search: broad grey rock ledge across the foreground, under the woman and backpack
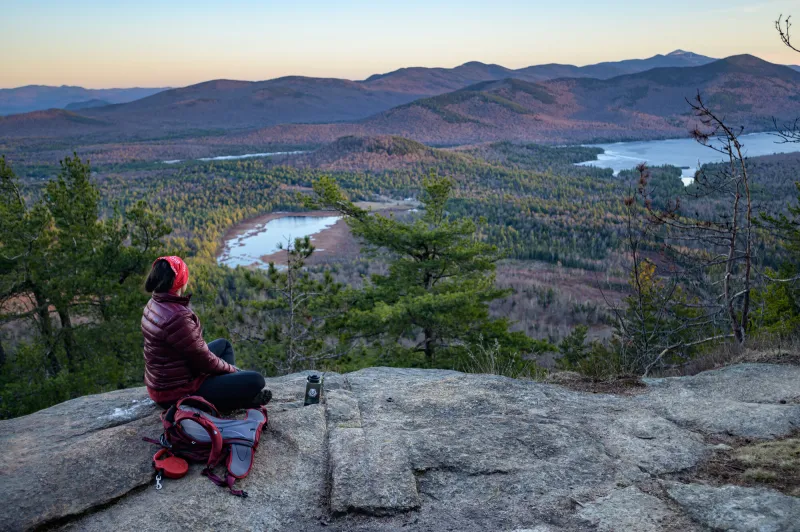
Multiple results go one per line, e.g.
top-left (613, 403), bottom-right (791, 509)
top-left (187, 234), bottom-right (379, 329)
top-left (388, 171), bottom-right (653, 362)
top-left (0, 364), bottom-right (800, 531)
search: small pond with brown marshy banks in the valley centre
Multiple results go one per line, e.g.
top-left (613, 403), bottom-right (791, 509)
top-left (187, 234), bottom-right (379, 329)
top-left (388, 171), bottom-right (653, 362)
top-left (217, 215), bottom-right (340, 268)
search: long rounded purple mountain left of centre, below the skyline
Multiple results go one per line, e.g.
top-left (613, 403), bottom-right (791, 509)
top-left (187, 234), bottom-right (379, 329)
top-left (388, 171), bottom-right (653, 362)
top-left (0, 76), bottom-right (434, 139)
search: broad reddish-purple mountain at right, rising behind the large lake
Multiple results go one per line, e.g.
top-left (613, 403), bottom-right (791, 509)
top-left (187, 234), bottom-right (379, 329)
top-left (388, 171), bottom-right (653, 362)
top-left (233, 55), bottom-right (800, 144)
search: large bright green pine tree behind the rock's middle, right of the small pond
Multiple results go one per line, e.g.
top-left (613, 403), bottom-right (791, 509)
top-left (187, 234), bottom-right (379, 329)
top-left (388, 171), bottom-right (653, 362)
top-left (306, 175), bottom-right (544, 367)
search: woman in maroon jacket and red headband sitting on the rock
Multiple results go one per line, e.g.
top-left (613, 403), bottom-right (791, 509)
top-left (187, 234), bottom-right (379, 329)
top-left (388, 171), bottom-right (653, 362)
top-left (142, 256), bottom-right (272, 410)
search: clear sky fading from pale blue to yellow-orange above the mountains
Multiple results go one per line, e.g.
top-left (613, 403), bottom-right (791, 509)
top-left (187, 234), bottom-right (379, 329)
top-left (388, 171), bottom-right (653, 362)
top-left (0, 0), bottom-right (800, 88)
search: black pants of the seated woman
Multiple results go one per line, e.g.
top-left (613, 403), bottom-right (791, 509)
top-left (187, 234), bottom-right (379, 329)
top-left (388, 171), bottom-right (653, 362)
top-left (195, 339), bottom-right (264, 410)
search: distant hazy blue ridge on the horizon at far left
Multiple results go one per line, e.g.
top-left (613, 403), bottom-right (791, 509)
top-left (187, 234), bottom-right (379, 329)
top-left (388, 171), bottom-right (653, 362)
top-left (0, 85), bottom-right (165, 116)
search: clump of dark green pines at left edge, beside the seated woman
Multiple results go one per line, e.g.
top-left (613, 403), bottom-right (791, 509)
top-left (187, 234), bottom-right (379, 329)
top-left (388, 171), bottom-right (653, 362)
top-left (0, 157), bottom-right (170, 417)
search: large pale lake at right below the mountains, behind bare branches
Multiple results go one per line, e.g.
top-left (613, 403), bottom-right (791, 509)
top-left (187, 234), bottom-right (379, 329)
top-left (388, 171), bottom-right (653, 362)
top-left (578, 133), bottom-right (800, 184)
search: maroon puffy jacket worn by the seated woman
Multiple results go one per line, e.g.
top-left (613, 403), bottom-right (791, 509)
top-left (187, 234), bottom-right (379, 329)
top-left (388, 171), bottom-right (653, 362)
top-left (142, 292), bottom-right (236, 403)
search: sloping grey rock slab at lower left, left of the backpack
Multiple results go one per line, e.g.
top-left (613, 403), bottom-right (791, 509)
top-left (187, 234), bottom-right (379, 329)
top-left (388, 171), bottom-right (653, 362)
top-left (0, 388), bottom-right (161, 530)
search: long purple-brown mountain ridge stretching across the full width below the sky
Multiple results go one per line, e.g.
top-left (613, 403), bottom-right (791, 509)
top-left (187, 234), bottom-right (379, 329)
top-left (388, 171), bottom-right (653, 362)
top-left (0, 52), bottom-right (800, 145)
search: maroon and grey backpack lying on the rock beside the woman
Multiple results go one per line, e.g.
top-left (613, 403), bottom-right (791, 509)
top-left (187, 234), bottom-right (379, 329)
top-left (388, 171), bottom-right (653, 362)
top-left (144, 396), bottom-right (268, 497)
